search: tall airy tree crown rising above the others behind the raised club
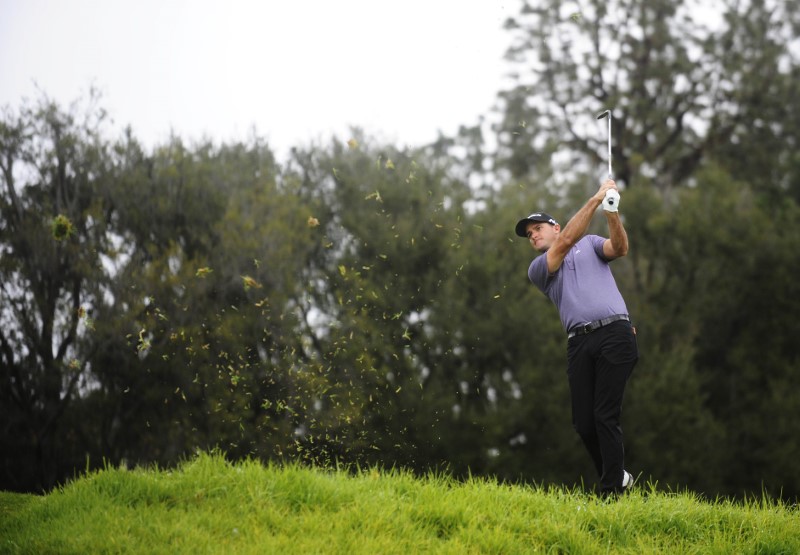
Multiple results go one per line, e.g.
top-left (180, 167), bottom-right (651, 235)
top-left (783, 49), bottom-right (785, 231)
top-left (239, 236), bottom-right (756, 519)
top-left (496, 0), bottom-right (798, 189)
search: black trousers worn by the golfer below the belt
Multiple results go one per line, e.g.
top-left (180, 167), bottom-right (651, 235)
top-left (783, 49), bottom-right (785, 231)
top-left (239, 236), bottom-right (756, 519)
top-left (567, 320), bottom-right (639, 493)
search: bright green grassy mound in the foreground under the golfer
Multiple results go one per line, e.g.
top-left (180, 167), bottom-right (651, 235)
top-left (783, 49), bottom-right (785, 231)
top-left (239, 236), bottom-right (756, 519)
top-left (0, 454), bottom-right (800, 554)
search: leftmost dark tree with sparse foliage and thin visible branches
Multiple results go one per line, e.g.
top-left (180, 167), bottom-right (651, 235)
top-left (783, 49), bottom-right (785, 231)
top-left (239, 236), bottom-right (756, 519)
top-left (0, 93), bottom-right (117, 489)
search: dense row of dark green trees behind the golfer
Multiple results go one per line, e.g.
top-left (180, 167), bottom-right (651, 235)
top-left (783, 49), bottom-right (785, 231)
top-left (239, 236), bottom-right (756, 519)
top-left (0, 0), bottom-right (800, 496)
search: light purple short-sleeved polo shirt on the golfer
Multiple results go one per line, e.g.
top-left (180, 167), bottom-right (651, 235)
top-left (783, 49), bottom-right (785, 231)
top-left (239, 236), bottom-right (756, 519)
top-left (528, 235), bottom-right (628, 331)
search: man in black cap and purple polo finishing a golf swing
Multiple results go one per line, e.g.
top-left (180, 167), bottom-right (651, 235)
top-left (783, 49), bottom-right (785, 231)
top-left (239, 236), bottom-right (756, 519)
top-left (515, 179), bottom-right (639, 495)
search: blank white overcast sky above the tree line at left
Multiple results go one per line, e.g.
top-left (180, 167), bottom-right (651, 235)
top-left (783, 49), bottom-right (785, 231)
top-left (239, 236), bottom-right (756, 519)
top-left (0, 0), bottom-right (520, 157)
